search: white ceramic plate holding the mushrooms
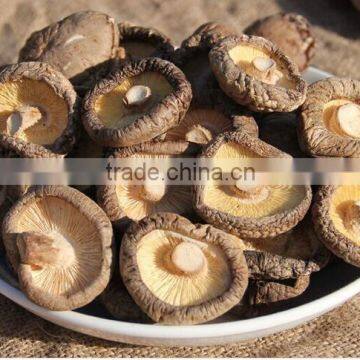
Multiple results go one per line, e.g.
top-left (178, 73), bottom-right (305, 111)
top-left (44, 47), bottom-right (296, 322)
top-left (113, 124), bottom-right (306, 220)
top-left (0, 68), bottom-right (360, 346)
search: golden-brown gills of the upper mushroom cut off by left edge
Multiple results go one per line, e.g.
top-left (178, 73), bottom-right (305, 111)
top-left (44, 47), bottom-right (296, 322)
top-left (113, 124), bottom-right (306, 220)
top-left (0, 79), bottom-right (69, 145)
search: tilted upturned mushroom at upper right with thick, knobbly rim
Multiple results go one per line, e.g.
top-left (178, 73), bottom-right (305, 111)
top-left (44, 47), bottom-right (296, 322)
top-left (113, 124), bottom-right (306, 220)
top-left (209, 35), bottom-right (307, 112)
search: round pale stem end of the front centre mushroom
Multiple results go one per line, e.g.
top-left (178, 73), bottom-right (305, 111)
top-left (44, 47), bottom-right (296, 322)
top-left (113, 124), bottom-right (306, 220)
top-left (171, 241), bottom-right (206, 274)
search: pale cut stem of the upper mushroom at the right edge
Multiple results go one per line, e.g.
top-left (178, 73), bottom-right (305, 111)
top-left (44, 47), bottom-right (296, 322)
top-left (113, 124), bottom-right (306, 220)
top-left (336, 103), bottom-right (360, 138)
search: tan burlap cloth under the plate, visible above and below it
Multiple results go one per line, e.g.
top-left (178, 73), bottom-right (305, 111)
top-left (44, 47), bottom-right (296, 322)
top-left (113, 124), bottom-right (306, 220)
top-left (0, 0), bottom-right (360, 357)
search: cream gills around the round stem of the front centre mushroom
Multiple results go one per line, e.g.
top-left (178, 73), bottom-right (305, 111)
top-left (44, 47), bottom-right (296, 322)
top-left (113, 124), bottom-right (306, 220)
top-left (137, 230), bottom-right (232, 306)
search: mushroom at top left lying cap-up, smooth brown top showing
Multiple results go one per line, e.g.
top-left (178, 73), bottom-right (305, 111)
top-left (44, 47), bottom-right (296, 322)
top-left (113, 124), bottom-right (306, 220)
top-left (19, 11), bottom-right (119, 85)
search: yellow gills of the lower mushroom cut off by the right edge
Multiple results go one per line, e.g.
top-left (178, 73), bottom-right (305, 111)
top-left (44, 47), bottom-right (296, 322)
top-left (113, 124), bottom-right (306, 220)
top-left (329, 185), bottom-right (360, 246)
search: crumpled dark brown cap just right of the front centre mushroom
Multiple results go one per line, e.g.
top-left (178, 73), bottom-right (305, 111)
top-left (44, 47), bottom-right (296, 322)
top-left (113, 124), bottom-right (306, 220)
top-left (244, 217), bottom-right (330, 280)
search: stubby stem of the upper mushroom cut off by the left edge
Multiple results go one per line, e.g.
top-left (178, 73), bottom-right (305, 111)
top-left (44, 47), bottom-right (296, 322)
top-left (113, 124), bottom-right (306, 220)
top-left (6, 105), bottom-right (46, 136)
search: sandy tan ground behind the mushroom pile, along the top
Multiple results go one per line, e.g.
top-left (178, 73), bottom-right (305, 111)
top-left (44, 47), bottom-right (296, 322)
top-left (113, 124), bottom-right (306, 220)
top-left (0, 0), bottom-right (360, 79)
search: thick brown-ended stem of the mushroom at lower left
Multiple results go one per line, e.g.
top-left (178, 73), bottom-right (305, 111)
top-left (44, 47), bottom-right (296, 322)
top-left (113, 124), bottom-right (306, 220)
top-left (16, 232), bottom-right (74, 269)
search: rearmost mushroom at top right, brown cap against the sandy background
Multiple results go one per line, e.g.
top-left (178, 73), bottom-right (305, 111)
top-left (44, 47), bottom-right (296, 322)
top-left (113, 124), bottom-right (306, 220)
top-left (244, 13), bottom-right (315, 71)
